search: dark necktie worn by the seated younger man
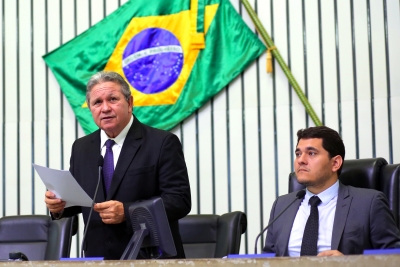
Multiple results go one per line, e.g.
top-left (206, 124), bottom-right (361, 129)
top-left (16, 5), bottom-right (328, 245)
top-left (300, 196), bottom-right (321, 256)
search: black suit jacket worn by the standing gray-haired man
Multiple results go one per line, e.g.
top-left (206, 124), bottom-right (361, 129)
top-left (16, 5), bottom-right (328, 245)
top-left (63, 118), bottom-right (191, 259)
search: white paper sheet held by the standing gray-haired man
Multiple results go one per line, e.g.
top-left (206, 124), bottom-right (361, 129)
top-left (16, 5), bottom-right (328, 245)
top-left (32, 163), bottom-right (93, 208)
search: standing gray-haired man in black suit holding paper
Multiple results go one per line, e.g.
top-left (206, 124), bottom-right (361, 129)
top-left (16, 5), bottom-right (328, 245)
top-left (45, 72), bottom-right (191, 259)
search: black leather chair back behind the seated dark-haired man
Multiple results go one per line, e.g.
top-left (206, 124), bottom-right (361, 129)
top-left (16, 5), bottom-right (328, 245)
top-left (289, 158), bottom-right (400, 228)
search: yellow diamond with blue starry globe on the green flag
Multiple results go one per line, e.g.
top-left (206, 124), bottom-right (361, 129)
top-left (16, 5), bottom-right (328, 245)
top-left (104, 4), bottom-right (218, 106)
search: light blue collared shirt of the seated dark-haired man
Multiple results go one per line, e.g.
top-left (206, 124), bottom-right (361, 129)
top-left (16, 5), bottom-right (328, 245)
top-left (288, 181), bottom-right (339, 257)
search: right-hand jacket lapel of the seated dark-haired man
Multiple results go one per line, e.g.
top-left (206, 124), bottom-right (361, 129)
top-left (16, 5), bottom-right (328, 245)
top-left (331, 182), bottom-right (353, 250)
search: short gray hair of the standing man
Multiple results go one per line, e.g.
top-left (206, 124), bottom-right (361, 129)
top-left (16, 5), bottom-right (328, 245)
top-left (86, 71), bottom-right (132, 107)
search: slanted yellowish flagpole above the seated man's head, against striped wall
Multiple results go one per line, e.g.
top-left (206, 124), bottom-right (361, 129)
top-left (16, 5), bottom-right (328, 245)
top-left (241, 0), bottom-right (322, 126)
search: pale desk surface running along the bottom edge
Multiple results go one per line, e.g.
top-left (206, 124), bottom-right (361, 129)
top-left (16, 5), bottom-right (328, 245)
top-left (0, 255), bottom-right (400, 267)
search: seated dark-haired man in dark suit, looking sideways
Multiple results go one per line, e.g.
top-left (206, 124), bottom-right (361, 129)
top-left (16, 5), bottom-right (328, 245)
top-left (263, 126), bottom-right (400, 256)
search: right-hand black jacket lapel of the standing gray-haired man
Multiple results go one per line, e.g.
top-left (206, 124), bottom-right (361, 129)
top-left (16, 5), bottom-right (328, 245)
top-left (106, 117), bottom-right (143, 200)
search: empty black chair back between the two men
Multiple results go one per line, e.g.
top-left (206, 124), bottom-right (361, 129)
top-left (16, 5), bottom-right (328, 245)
top-left (179, 211), bottom-right (247, 259)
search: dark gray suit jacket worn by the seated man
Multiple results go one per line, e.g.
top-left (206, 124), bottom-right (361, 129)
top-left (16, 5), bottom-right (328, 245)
top-left (263, 183), bottom-right (400, 256)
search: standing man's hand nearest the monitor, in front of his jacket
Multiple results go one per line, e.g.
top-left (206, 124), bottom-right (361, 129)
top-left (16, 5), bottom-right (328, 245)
top-left (93, 200), bottom-right (125, 224)
